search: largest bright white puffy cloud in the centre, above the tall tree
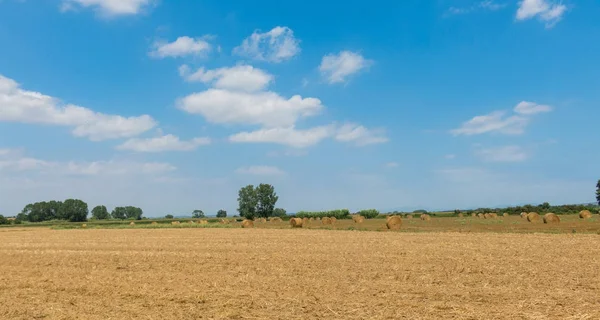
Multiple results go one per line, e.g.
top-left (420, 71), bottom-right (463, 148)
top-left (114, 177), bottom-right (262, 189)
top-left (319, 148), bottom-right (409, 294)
top-left (178, 89), bottom-right (323, 128)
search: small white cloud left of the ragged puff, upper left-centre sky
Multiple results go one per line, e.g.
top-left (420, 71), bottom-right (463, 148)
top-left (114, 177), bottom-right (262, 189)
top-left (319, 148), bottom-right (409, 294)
top-left (149, 36), bottom-right (212, 58)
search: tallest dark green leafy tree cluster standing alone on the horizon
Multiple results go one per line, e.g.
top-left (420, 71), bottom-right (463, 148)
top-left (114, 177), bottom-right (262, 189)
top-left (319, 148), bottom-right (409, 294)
top-left (238, 183), bottom-right (279, 220)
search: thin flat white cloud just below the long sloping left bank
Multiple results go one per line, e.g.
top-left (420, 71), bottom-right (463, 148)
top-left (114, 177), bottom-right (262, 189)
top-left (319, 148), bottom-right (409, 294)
top-left (117, 134), bottom-right (211, 152)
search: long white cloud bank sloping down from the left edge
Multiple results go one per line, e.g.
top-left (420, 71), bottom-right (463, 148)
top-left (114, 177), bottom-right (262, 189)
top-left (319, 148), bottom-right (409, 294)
top-left (0, 75), bottom-right (156, 141)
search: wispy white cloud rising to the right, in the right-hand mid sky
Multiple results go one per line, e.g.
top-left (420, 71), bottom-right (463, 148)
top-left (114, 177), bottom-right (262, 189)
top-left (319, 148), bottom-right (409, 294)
top-left (450, 101), bottom-right (552, 136)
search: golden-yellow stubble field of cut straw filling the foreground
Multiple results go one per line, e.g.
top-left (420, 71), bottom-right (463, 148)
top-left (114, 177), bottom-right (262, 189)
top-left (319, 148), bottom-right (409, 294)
top-left (0, 228), bottom-right (600, 319)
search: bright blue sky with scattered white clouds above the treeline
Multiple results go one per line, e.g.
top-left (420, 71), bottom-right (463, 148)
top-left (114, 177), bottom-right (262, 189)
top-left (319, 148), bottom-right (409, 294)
top-left (0, 0), bottom-right (600, 216)
